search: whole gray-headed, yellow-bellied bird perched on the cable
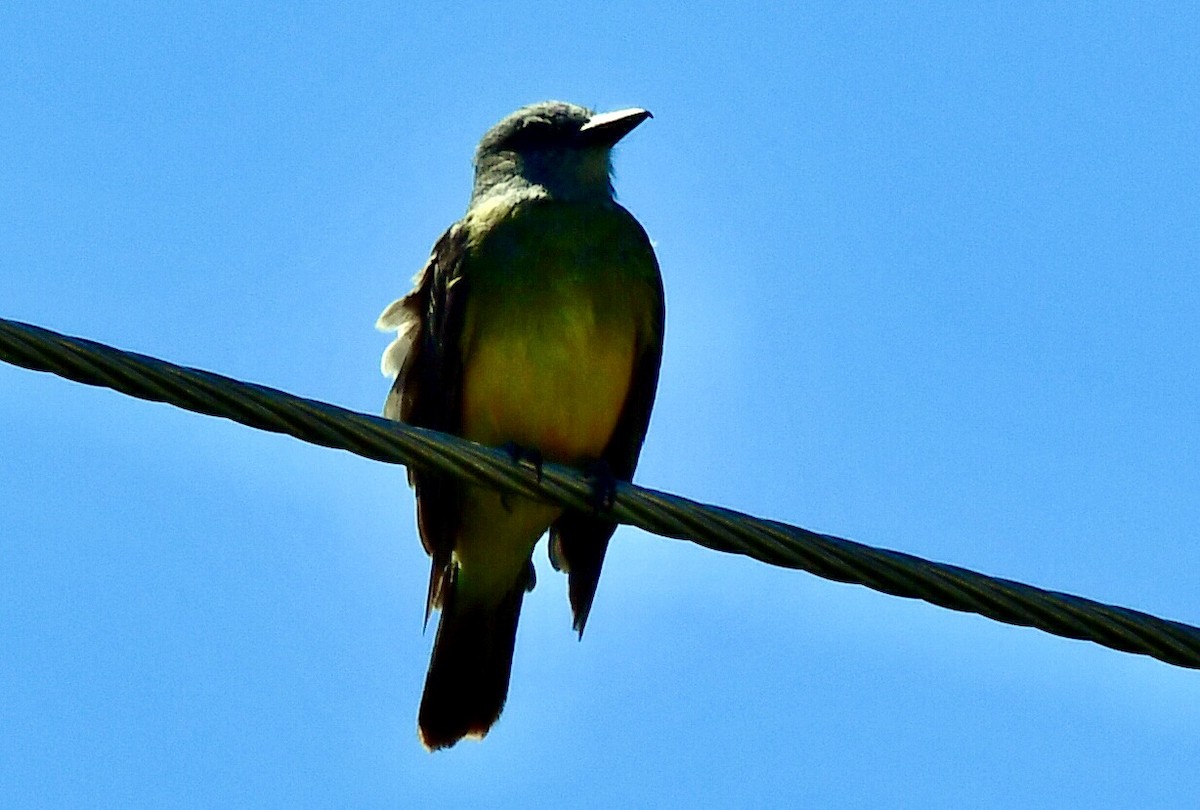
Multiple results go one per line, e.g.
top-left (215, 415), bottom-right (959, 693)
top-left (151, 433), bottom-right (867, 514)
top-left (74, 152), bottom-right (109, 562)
top-left (377, 101), bottom-right (665, 750)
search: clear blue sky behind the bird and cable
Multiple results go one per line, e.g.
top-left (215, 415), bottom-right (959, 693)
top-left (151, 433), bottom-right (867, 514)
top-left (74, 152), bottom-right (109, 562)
top-left (0, 1), bottom-right (1200, 808)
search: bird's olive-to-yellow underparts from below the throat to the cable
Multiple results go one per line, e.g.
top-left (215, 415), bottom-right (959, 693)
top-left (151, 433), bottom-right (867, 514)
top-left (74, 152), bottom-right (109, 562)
top-left (460, 203), bottom-right (658, 463)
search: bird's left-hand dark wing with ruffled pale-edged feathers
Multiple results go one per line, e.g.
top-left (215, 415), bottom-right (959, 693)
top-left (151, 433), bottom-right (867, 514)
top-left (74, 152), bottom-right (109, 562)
top-left (380, 223), bottom-right (467, 619)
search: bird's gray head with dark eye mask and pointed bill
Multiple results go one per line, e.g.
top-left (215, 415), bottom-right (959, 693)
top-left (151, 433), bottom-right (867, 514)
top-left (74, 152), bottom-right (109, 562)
top-left (472, 101), bottom-right (650, 203)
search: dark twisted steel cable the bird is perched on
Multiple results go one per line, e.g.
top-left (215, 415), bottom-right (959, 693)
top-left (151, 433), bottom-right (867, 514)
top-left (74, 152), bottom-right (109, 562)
top-left (7, 318), bottom-right (1200, 670)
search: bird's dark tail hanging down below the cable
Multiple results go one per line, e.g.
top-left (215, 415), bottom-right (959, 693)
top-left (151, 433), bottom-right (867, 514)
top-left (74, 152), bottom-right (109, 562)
top-left (418, 578), bottom-right (526, 751)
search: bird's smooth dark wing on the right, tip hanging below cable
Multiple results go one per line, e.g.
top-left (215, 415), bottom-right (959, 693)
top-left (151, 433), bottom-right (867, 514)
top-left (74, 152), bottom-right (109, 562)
top-left (550, 217), bottom-right (666, 636)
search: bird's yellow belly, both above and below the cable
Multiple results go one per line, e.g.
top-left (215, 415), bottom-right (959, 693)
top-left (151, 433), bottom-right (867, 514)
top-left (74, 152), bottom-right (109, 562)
top-left (455, 295), bottom-right (636, 600)
